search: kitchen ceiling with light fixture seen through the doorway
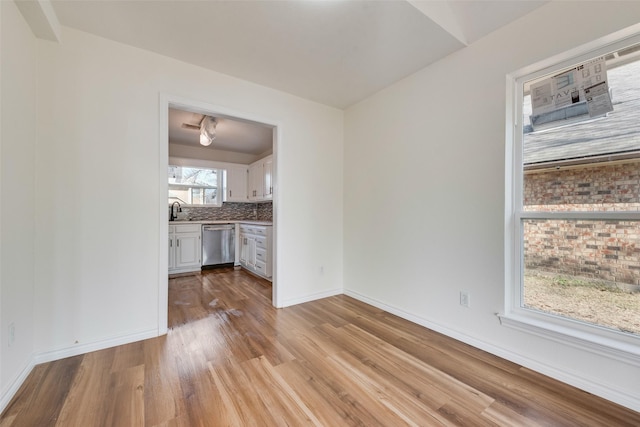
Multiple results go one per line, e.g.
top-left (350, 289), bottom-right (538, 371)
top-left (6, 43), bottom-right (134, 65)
top-left (169, 108), bottom-right (273, 156)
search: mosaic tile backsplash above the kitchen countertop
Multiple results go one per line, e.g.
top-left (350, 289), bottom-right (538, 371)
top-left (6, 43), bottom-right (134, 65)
top-left (181, 202), bottom-right (273, 221)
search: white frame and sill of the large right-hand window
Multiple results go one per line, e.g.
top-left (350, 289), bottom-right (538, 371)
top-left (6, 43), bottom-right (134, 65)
top-left (498, 25), bottom-right (640, 366)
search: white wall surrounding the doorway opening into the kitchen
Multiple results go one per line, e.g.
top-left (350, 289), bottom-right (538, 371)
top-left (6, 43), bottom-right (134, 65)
top-left (35, 28), bottom-right (343, 359)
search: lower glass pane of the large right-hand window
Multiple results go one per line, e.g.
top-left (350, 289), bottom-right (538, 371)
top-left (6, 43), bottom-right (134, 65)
top-left (522, 219), bottom-right (640, 334)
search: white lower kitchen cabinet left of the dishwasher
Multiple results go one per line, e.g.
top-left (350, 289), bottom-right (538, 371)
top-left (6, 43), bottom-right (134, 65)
top-left (169, 224), bottom-right (202, 274)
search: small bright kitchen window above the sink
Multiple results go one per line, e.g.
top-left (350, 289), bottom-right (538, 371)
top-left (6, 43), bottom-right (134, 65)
top-left (169, 166), bottom-right (222, 206)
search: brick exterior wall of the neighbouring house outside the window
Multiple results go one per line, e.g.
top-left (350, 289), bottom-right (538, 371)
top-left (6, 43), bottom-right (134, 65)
top-left (524, 161), bottom-right (640, 286)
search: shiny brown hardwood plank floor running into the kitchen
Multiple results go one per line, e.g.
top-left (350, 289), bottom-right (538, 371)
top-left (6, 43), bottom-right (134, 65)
top-left (0, 269), bottom-right (640, 427)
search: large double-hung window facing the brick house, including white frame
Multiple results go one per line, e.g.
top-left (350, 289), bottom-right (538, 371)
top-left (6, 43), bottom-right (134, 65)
top-left (501, 29), bottom-right (640, 361)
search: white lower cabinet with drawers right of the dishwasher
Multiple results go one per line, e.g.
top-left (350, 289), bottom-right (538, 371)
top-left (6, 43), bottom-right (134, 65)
top-left (240, 224), bottom-right (273, 279)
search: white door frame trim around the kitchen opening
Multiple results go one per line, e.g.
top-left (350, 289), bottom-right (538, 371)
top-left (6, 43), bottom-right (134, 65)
top-left (158, 93), bottom-right (282, 336)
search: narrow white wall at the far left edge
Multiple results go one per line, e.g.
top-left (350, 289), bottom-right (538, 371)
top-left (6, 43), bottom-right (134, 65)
top-left (0, 1), bottom-right (37, 409)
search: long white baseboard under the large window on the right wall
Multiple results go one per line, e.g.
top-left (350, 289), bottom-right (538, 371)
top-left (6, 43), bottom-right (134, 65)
top-left (344, 289), bottom-right (640, 412)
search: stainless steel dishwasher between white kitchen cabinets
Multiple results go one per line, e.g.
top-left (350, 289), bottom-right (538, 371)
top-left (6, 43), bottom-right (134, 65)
top-left (202, 224), bottom-right (236, 267)
